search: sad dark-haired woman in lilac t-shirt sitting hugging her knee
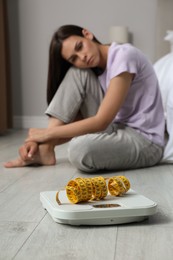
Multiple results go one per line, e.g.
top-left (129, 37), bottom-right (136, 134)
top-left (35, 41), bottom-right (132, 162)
top-left (5, 25), bottom-right (165, 172)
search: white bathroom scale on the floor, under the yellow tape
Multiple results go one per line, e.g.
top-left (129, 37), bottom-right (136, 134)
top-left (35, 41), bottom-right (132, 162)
top-left (40, 189), bottom-right (157, 225)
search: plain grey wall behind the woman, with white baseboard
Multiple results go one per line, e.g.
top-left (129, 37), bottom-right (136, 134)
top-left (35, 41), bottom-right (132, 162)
top-left (7, 0), bottom-right (170, 128)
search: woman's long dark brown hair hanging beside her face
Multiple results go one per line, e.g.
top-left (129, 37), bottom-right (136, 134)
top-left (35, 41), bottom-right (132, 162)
top-left (47, 25), bottom-right (100, 104)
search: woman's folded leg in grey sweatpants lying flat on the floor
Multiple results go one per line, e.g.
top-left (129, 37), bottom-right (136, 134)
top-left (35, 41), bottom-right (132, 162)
top-left (68, 124), bottom-right (163, 172)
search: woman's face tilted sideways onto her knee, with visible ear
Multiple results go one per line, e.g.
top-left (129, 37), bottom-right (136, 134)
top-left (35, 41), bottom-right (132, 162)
top-left (61, 29), bottom-right (101, 68)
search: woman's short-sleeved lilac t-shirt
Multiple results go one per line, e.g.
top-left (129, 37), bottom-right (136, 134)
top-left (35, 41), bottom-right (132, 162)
top-left (99, 43), bottom-right (165, 146)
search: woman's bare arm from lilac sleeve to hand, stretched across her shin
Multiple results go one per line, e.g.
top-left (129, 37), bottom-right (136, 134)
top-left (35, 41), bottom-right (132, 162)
top-left (26, 72), bottom-right (134, 143)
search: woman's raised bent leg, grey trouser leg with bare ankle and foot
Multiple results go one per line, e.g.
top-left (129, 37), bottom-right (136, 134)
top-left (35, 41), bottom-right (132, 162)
top-left (4, 67), bottom-right (103, 168)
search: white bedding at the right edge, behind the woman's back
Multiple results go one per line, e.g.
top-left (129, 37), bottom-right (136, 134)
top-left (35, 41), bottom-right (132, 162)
top-left (154, 52), bottom-right (173, 163)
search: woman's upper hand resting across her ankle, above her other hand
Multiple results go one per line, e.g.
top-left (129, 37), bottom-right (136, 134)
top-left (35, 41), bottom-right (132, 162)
top-left (25, 128), bottom-right (51, 143)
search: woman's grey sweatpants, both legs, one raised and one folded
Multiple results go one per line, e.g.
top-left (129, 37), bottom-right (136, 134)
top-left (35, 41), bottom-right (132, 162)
top-left (46, 67), bottom-right (163, 172)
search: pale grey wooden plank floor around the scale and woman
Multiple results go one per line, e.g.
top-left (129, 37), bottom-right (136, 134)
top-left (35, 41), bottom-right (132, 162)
top-left (0, 130), bottom-right (173, 260)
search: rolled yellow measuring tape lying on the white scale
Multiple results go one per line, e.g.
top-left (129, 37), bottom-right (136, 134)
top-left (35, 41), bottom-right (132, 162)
top-left (56, 176), bottom-right (130, 205)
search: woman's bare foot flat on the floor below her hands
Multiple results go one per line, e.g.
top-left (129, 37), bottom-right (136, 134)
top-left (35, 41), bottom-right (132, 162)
top-left (4, 144), bottom-right (56, 168)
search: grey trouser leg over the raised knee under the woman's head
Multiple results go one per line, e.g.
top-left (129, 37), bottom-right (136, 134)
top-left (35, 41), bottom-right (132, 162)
top-left (46, 67), bottom-right (103, 120)
